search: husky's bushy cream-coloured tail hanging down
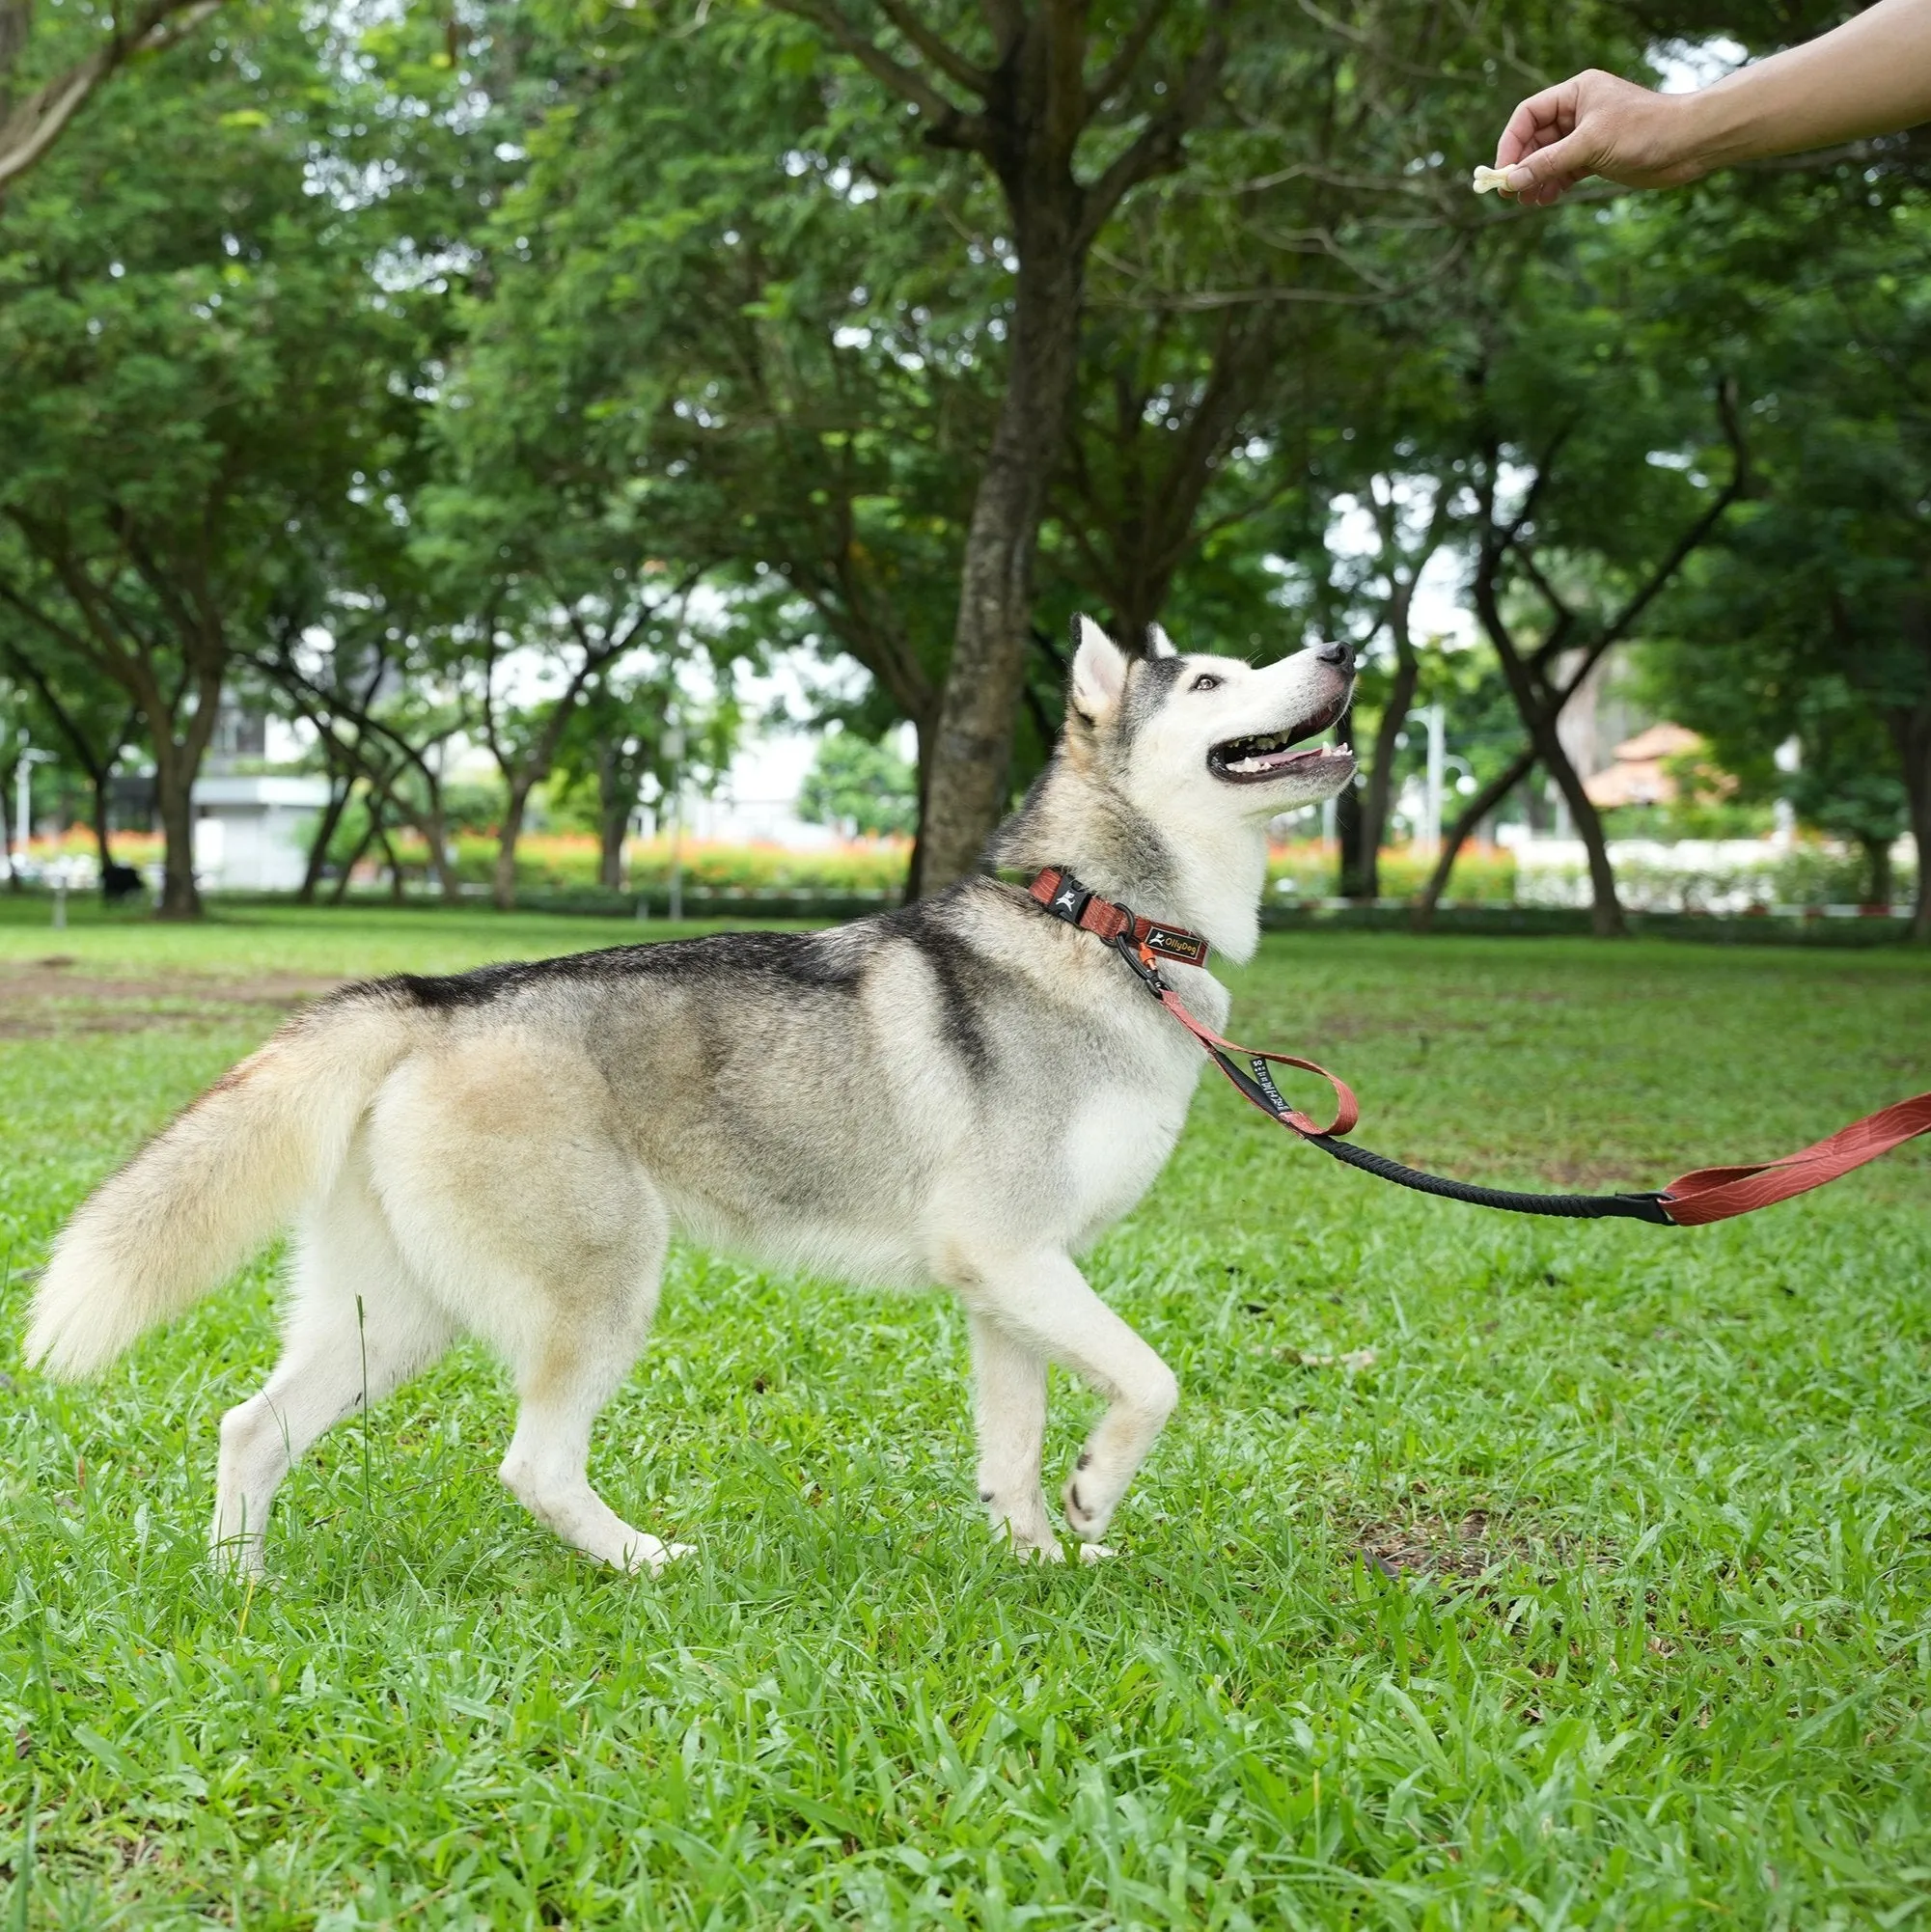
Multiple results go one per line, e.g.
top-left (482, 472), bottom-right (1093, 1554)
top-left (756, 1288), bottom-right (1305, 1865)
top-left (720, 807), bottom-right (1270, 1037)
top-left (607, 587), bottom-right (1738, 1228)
top-left (27, 987), bottom-right (417, 1381)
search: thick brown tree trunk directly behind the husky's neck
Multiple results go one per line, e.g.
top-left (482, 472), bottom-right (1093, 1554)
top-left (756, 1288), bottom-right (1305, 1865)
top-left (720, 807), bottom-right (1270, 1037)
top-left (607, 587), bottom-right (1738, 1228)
top-left (913, 196), bottom-right (1082, 895)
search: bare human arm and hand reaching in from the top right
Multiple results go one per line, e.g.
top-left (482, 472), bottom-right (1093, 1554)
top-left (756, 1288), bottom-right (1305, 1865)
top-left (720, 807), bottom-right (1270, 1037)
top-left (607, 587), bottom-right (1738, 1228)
top-left (1495, 0), bottom-right (1931, 207)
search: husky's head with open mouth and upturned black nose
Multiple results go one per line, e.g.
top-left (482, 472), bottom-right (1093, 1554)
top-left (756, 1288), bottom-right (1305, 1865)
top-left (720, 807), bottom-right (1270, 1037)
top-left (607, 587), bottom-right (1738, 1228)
top-left (1066, 617), bottom-right (1354, 825)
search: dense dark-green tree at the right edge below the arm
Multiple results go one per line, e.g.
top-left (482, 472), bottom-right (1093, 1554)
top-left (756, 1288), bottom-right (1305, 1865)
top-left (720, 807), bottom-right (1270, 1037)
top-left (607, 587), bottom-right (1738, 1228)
top-left (1614, 170), bottom-right (1931, 941)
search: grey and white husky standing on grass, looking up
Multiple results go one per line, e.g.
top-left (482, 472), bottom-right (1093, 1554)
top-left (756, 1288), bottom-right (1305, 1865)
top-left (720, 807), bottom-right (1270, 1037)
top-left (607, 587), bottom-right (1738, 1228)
top-left (27, 619), bottom-right (1354, 1571)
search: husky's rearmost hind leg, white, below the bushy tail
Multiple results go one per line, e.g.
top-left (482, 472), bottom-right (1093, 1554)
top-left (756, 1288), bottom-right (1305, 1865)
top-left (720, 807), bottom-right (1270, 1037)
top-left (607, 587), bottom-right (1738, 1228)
top-left (208, 1147), bottom-right (452, 1575)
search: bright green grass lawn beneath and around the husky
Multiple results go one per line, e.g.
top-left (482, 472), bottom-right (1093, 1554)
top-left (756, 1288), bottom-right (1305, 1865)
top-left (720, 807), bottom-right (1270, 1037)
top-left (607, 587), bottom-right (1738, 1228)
top-left (0, 902), bottom-right (1931, 1928)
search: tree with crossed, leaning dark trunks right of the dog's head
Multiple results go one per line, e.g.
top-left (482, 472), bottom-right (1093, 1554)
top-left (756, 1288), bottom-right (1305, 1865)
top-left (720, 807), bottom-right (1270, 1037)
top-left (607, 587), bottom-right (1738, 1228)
top-left (1418, 186), bottom-right (1752, 937)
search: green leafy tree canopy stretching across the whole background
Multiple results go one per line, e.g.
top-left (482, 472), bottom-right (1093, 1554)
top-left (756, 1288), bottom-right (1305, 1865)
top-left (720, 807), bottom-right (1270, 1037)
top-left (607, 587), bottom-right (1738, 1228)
top-left (11, 0), bottom-right (1931, 919)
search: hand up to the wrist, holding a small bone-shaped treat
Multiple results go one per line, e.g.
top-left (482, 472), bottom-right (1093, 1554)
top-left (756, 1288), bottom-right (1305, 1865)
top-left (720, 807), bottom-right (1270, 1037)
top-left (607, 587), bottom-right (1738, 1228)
top-left (1495, 68), bottom-right (1709, 208)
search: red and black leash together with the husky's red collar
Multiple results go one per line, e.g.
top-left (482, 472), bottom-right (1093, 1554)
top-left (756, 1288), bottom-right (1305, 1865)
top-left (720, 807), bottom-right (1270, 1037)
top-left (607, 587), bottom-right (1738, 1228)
top-left (1030, 866), bottom-right (1931, 1227)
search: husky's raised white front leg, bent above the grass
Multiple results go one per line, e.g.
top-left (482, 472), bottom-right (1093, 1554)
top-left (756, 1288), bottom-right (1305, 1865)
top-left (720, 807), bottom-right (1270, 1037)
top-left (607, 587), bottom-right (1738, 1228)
top-left (959, 1252), bottom-right (1180, 1546)
